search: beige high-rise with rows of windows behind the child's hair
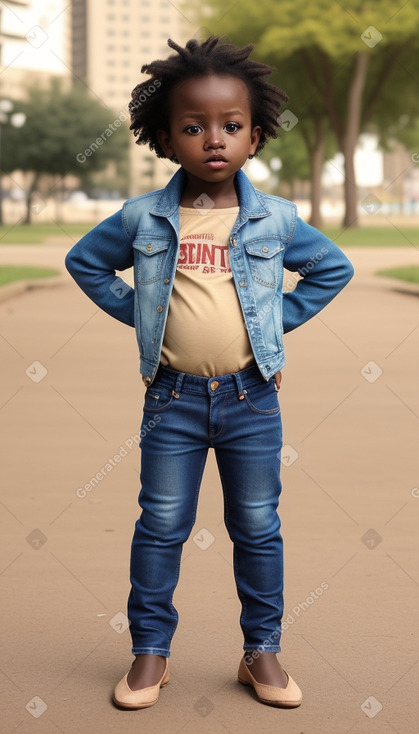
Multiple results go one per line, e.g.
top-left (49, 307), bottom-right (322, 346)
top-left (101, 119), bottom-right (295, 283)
top-left (72, 0), bottom-right (190, 195)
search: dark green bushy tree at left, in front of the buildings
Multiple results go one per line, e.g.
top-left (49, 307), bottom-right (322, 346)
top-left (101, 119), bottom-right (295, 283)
top-left (2, 79), bottom-right (129, 223)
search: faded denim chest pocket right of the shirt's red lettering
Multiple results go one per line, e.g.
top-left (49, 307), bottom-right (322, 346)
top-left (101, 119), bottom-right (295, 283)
top-left (244, 237), bottom-right (285, 288)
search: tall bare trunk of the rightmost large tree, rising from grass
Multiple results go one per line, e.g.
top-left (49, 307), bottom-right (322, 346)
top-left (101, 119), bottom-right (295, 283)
top-left (342, 51), bottom-right (369, 227)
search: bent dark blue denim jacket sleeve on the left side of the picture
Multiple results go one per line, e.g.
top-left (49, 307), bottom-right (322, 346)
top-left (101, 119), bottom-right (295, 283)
top-left (65, 209), bottom-right (134, 326)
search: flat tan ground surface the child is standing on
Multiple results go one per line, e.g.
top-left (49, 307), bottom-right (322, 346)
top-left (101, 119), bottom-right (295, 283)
top-left (0, 246), bottom-right (419, 734)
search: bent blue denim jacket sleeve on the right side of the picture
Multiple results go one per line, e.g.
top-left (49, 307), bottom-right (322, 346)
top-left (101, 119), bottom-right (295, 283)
top-left (283, 217), bottom-right (354, 333)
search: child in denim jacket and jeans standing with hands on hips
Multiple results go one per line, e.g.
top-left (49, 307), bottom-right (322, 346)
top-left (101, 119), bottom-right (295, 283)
top-left (66, 38), bottom-right (353, 709)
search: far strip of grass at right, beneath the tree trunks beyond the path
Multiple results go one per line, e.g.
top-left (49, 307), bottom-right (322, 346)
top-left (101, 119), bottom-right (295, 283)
top-left (322, 227), bottom-right (419, 247)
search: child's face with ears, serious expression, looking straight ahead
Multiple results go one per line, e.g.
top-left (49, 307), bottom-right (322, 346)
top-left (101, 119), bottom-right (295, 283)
top-left (158, 74), bottom-right (261, 190)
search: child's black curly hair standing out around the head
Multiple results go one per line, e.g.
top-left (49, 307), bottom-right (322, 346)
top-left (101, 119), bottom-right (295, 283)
top-left (128, 36), bottom-right (288, 158)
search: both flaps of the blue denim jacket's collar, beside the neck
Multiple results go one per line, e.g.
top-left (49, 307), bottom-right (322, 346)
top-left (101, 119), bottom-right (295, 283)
top-left (150, 168), bottom-right (271, 221)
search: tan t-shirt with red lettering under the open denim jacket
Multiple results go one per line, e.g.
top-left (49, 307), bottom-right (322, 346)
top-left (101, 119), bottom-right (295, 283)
top-left (161, 206), bottom-right (255, 377)
